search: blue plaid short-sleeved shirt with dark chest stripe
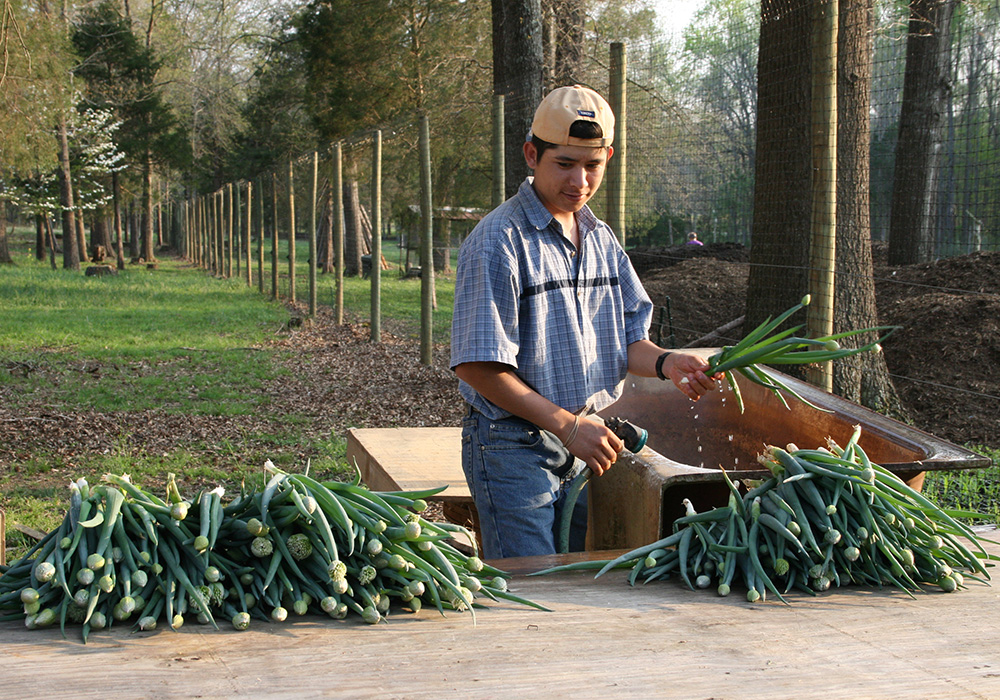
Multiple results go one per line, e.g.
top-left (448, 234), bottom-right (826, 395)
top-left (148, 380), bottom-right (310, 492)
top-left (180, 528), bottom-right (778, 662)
top-left (451, 178), bottom-right (653, 419)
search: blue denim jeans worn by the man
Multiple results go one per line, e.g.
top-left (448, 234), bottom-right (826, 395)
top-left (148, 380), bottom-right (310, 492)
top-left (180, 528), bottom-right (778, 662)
top-left (462, 409), bottom-right (587, 559)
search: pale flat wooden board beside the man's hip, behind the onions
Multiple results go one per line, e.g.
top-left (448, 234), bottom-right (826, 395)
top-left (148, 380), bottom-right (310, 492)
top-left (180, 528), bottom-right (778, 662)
top-left (347, 428), bottom-right (472, 503)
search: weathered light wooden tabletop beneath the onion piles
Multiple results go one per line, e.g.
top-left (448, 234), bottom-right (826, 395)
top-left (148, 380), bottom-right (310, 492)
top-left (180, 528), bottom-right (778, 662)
top-left (0, 546), bottom-right (1000, 700)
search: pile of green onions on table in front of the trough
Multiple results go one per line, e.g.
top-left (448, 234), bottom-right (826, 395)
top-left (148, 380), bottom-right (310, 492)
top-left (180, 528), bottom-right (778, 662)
top-left (533, 428), bottom-right (998, 602)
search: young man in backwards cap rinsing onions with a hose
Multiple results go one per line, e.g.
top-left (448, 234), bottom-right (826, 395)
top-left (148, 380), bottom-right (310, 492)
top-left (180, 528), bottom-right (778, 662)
top-left (451, 85), bottom-right (715, 558)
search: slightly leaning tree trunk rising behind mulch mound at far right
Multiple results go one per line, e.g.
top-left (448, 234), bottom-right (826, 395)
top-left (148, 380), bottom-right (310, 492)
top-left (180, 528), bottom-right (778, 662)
top-left (889, 0), bottom-right (955, 265)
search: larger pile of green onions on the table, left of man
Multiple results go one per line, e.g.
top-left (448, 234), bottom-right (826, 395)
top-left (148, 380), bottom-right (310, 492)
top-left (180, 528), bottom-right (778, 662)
top-left (0, 462), bottom-right (544, 642)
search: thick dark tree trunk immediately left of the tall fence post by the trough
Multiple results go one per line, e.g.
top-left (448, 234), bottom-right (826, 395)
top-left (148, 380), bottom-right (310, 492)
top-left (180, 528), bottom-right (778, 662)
top-left (744, 0), bottom-right (812, 356)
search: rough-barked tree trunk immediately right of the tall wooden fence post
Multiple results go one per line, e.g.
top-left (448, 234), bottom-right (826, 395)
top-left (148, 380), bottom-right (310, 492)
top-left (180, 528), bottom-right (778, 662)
top-left (833, 0), bottom-right (905, 418)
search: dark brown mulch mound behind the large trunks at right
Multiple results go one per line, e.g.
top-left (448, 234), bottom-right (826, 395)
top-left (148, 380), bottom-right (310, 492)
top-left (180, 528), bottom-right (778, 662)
top-left (632, 244), bottom-right (1000, 447)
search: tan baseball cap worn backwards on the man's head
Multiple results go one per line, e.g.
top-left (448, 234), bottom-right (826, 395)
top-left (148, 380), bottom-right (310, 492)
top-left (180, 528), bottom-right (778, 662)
top-left (531, 85), bottom-right (615, 148)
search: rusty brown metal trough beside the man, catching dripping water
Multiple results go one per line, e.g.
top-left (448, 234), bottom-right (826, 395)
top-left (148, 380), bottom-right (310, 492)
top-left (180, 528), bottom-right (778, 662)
top-left (588, 360), bottom-right (990, 549)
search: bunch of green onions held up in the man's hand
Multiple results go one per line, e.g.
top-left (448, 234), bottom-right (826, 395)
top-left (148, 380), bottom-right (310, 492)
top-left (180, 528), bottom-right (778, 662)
top-left (706, 294), bottom-right (896, 413)
